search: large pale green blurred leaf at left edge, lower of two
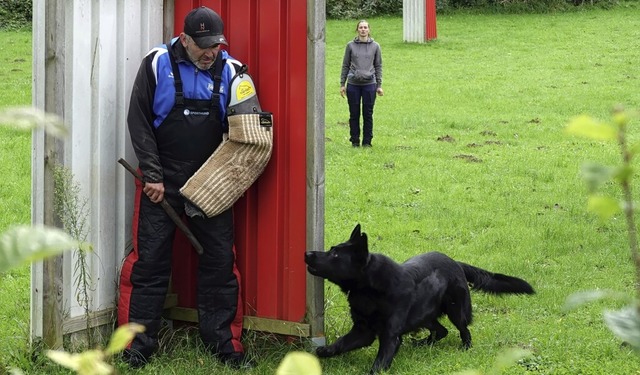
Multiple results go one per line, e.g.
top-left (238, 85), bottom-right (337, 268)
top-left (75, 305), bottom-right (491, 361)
top-left (0, 225), bottom-right (80, 273)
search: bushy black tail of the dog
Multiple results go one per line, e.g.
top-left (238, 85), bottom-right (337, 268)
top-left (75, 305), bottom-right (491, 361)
top-left (458, 262), bottom-right (535, 294)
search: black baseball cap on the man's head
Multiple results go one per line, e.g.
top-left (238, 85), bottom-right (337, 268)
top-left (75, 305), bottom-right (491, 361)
top-left (184, 7), bottom-right (229, 48)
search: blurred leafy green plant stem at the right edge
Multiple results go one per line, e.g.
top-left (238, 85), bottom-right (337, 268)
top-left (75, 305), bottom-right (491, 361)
top-left (566, 108), bottom-right (640, 351)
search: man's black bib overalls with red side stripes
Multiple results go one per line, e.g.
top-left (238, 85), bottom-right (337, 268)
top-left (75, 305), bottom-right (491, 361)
top-left (118, 45), bottom-right (243, 359)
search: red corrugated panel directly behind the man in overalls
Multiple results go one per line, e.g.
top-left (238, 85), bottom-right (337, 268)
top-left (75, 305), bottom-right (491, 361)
top-left (172, 0), bottom-right (307, 322)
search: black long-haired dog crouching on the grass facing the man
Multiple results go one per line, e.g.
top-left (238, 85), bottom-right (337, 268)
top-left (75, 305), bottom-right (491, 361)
top-left (305, 224), bottom-right (535, 374)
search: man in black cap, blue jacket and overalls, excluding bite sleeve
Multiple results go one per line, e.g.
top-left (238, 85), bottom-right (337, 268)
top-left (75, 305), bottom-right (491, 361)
top-left (118, 7), bottom-right (251, 368)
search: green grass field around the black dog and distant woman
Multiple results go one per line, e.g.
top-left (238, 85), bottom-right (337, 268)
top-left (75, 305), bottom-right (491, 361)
top-left (0, 3), bottom-right (640, 374)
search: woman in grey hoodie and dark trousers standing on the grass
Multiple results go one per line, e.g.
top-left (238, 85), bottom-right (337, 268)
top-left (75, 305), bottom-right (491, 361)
top-left (340, 20), bottom-right (384, 147)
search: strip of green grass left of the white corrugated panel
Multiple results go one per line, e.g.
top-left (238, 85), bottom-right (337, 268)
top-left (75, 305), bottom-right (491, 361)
top-left (0, 32), bottom-right (31, 374)
